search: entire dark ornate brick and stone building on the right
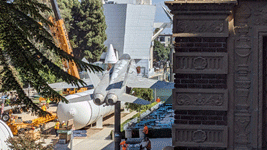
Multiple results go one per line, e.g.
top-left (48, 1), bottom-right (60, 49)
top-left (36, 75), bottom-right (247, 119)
top-left (165, 0), bottom-right (267, 150)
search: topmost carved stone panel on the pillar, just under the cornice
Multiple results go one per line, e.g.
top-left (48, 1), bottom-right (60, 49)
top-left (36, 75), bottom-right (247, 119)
top-left (174, 19), bottom-right (224, 33)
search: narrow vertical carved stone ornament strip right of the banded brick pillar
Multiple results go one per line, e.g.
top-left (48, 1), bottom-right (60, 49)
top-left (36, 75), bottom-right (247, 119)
top-left (234, 4), bottom-right (251, 150)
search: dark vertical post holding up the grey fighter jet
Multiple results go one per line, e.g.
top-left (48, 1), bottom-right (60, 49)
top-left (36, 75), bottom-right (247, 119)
top-left (114, 101), bottom-right (121, 150)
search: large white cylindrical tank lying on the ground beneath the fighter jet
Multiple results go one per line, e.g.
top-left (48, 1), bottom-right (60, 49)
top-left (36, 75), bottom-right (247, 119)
top-left (57, 90), bottom-right (124, 129)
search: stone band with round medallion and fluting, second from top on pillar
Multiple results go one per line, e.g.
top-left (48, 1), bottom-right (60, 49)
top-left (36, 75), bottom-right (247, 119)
top-left (174, 53), bottom-right (228, 74)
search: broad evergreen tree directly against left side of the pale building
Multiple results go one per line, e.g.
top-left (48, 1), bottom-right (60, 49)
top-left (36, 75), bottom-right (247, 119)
top-left (70, 0), bottom-right (107, 62)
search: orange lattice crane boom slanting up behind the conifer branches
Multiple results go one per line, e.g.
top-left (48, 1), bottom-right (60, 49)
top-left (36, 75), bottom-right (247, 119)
top-left (48, 0), bottom-right (80, 79)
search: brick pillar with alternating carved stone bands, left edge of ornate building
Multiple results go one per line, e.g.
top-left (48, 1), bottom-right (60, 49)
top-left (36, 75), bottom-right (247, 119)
top-left (165, 0), bottom-right (238, 149)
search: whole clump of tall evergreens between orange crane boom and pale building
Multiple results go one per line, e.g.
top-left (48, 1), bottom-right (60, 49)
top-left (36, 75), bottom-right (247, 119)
top-left (40, 0), bottom-right (107, 62)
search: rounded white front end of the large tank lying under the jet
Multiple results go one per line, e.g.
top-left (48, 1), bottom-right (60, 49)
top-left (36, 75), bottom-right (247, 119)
top-left (57, 101), bottom-right (92, 129)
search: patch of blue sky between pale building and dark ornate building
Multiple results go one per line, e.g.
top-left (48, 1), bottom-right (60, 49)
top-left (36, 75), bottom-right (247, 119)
top-left (152, 0), bottom-right (172, 34)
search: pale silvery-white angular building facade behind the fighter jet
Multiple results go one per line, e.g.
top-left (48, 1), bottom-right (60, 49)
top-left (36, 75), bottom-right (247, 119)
top-left (103, 0), bottom-right (156, 77)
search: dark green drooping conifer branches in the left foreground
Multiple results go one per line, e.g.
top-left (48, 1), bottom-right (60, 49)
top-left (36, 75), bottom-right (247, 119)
top-left (0, 0), bottom-right (102, 115)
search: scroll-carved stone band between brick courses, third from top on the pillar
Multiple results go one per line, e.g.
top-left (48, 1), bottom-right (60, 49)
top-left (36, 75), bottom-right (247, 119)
top-left (173, 89), bottom-right (228, 110)
